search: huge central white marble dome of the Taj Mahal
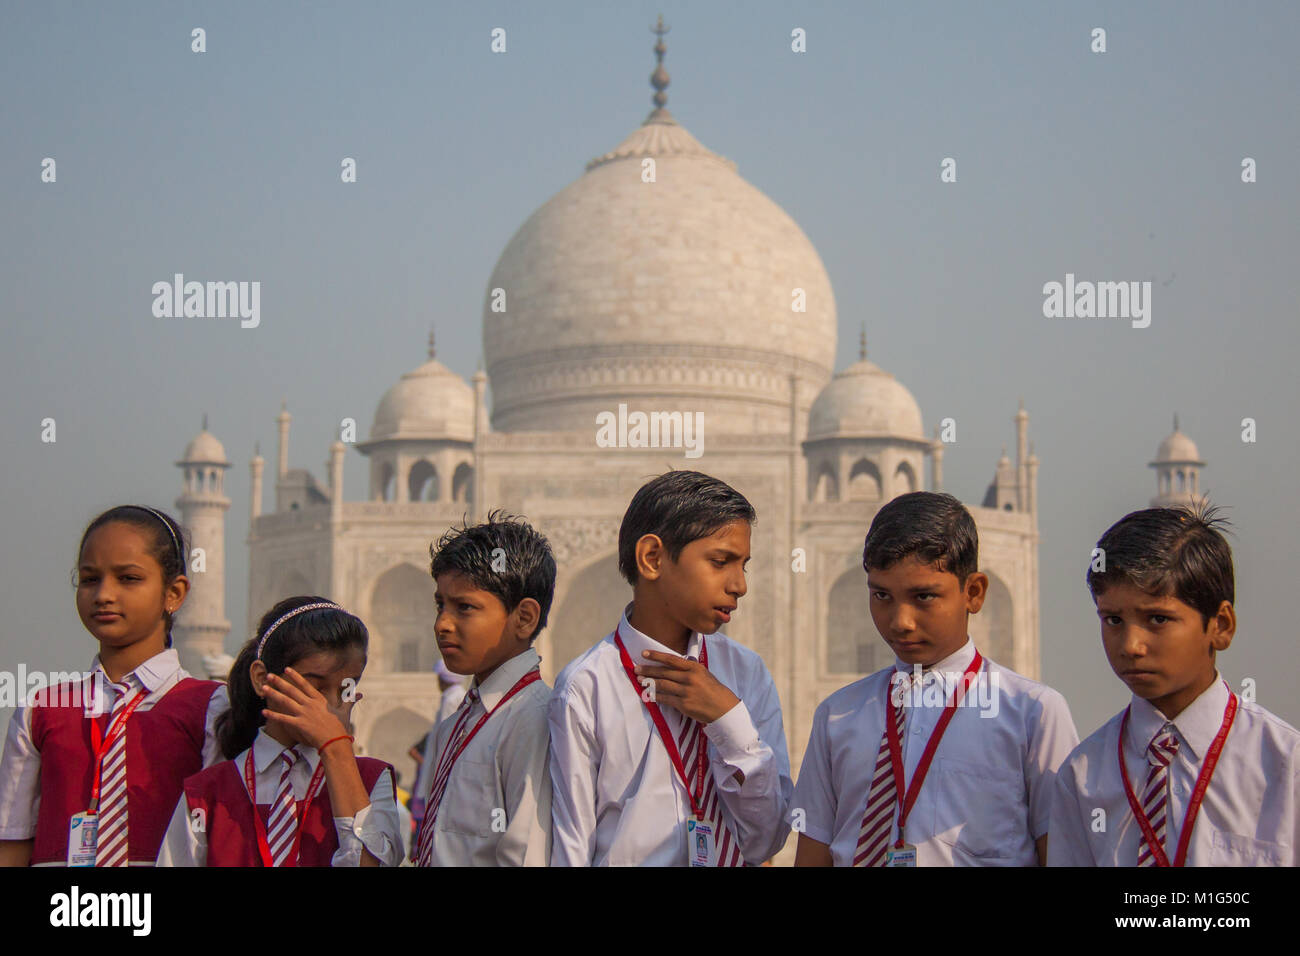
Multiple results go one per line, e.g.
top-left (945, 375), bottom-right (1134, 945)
top-left (484, 109), bottom-right (836, 433)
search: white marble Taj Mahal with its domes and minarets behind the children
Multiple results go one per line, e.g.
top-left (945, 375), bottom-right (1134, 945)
top-left (154, 35), bottom-right (1204, 786)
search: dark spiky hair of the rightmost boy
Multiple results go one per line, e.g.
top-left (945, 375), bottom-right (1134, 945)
top-left (1088, 502), bottom-right (1236, 630)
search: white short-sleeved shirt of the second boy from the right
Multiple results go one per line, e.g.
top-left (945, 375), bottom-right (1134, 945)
top-left (790, 637), bottom-right (1079, 866)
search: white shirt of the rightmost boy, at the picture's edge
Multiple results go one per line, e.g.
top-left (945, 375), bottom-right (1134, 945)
top-left (1048, 672), bottom-right (1300, 866)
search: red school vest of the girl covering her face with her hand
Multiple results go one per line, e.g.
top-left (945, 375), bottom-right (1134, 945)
top-left (185, 754), bottom-right (397, 866)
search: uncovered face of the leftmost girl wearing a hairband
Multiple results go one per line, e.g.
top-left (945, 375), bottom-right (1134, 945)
top-left (77, 522), bottom-right (190, 652)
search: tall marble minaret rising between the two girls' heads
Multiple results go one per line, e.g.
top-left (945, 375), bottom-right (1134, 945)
top-left (172, 415), bottom-right (230, 676)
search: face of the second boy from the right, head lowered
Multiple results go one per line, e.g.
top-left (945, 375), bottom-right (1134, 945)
top-left (867, 557), bottom-right (988, 667)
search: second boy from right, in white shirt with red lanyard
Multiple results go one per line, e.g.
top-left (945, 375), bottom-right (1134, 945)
top-left (790, 492), bottom-right (1079, 866)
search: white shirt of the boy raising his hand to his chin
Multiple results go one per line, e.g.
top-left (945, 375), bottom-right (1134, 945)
top-left (550, 605), bottom-right (793, 866)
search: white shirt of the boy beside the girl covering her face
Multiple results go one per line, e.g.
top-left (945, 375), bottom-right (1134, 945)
top-left (424, 648), bottom-right (551, 866)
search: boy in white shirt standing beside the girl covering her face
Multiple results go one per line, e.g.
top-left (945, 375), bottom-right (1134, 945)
top-left (415, 511), bottom-right (555, 866)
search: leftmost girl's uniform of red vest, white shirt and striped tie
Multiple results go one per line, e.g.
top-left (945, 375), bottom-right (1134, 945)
top-left (0, 649), bottom-right (229, 866)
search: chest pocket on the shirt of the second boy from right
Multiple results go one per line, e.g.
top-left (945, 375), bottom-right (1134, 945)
top-left (923, 757), bottom-right (1030, 865)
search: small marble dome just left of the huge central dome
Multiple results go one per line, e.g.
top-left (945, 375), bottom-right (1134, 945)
top-left (371, 358), bottom-right (475, 441)
